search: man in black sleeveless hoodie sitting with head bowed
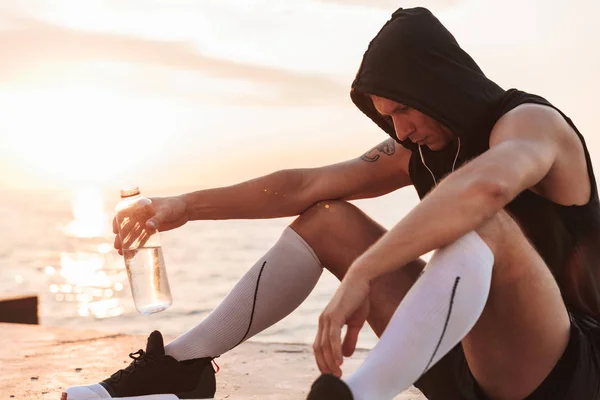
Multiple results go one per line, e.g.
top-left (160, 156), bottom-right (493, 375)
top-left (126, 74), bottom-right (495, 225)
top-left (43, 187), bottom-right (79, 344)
top-left (63, 8), bottom-right (600, 400)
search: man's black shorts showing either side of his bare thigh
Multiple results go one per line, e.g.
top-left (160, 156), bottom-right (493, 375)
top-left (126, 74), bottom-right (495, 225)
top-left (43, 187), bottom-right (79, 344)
top-left (415, 313), bottom-right (600, 400)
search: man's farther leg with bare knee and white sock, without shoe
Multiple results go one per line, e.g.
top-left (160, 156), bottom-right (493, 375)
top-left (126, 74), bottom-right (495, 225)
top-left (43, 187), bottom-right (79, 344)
top-left (166, 201), bottom-right (424, 360)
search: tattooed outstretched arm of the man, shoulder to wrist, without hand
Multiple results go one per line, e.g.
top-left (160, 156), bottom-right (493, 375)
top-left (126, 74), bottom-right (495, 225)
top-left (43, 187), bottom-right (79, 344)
top-left (181, 139), bottom-right (411, 220)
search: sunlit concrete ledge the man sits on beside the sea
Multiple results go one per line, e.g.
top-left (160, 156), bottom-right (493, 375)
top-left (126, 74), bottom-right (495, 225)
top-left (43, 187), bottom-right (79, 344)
top-left (0, 323), bottom-right (425, 400)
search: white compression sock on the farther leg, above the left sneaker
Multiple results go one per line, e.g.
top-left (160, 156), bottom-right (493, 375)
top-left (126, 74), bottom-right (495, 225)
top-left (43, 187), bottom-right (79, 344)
top-left (165, 227), bottom-right (323, 361)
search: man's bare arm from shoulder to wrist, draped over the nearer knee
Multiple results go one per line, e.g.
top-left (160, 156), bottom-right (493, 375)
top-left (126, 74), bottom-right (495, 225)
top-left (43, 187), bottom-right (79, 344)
top-left (349, 106), bottom-right (566, 281)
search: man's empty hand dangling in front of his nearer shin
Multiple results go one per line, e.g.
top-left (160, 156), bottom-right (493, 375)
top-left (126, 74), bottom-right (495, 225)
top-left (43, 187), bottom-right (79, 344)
top-left (313, 275), bottom-right (370, 378)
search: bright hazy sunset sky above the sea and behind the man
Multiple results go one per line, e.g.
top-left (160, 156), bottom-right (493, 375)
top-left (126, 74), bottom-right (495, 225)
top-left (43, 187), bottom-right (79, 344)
top-left (0, 0), bottom-right (600, 194)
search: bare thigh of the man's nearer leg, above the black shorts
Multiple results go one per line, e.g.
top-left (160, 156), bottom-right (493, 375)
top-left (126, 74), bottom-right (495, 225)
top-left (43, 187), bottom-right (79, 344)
top-left (462, 211), bottom-right (570, 400)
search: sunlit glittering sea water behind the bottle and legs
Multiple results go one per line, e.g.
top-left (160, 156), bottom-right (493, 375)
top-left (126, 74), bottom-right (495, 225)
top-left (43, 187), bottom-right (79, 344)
top-left (0, 186), bottom-right (418, 348)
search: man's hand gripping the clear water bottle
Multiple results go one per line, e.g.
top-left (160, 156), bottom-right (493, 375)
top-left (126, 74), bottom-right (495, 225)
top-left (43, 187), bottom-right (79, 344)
top-left (113, 196), bottom-right (188, 255)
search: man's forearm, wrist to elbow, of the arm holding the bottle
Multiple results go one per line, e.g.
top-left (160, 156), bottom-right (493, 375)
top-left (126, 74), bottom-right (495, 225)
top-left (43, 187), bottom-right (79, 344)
top-left (181, 169), bottom-right (312, 220)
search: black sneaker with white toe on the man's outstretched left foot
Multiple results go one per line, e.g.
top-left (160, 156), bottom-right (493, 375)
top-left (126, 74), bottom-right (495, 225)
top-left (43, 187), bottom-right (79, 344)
top-left (61, 331), bottom-right (216, 400)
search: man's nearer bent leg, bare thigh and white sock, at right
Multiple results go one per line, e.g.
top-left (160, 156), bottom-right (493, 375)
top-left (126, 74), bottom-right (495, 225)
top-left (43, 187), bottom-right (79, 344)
top-left (309, 211), bottom-right (570, 400)
